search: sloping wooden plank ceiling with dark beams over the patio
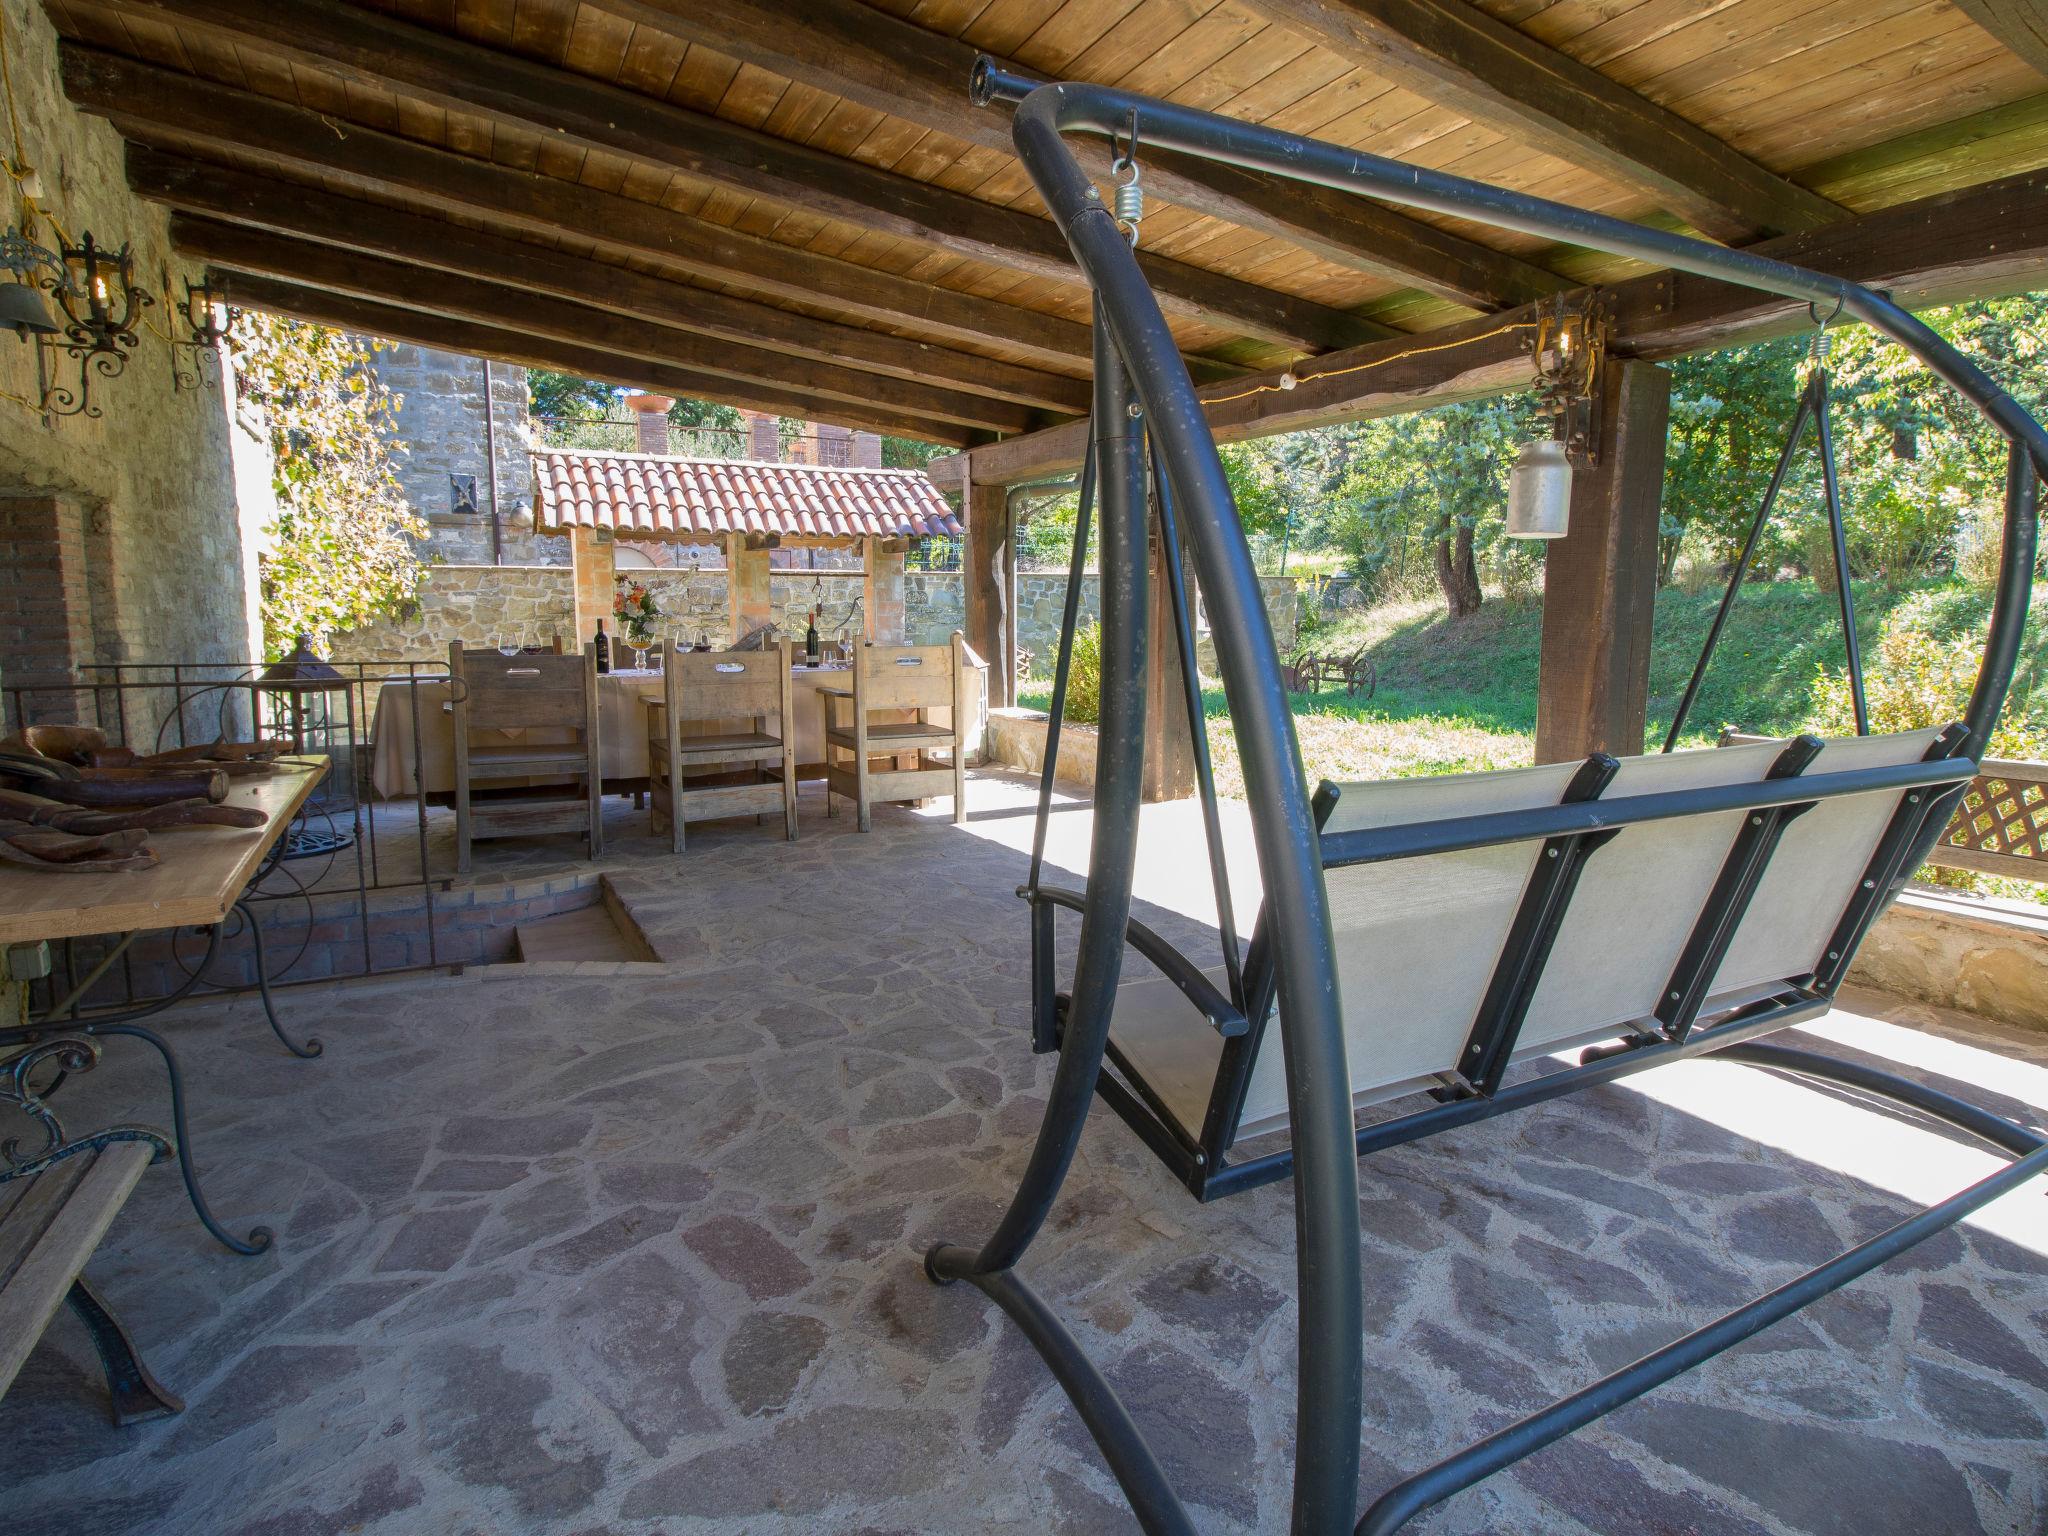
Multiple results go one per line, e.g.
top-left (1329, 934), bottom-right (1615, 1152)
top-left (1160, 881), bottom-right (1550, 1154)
top-left (47, 0), bottom-right (2048, 446)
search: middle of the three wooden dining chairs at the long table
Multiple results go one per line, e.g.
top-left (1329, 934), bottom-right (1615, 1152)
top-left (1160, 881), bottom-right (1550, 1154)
top-left (647, 639), bottom-right (797, 854)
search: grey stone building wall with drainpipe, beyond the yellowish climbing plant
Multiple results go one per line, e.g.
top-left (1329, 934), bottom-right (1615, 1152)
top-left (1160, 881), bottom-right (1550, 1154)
top-left (375, 344), bottom-right (569, 565)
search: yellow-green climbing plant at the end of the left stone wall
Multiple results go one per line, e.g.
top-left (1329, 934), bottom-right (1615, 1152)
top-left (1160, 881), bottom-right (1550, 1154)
top-left (233, 309), bottom-right (428, 655)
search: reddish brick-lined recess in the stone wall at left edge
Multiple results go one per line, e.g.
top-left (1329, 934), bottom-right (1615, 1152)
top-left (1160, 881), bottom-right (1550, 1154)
top-left (0, 496), bottom-right (92, 725)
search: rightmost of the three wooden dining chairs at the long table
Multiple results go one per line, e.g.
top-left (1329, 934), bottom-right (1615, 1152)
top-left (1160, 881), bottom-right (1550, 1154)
top-left (819, 631), bottom-right (969, 831)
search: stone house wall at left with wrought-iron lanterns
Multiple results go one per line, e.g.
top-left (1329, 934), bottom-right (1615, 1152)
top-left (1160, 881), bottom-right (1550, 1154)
top-left (0, 0), bottom-right (256, 731)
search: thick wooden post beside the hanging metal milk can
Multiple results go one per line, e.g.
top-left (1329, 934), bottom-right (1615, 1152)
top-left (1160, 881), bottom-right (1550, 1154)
top-left (1536, 358), bottom-right (1671, 762)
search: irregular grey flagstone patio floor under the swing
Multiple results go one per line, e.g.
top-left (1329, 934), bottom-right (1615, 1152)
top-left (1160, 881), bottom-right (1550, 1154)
top-left (0, 776), bottom-right (2048, 1536)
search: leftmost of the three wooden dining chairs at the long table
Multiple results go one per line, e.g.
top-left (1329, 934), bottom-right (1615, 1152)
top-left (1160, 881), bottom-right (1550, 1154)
top-left (449, 641), bottom-right (604, 874)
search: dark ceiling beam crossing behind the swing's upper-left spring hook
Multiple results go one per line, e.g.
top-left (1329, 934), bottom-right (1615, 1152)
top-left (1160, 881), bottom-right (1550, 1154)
top-left (569, 0), bottom-right (1567, 309)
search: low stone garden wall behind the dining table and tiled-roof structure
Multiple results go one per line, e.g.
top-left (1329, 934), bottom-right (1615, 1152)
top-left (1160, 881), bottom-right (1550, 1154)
top-left (334, 565), bottom-right (1294, 674)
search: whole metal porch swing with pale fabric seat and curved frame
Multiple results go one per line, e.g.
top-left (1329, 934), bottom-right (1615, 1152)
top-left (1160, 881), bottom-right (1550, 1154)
top-left (924, 59), bottom-right (2048, 1536)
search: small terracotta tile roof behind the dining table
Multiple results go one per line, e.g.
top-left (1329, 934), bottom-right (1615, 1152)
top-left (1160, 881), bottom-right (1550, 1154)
top-left (532, 449), bottom-right (961, 539)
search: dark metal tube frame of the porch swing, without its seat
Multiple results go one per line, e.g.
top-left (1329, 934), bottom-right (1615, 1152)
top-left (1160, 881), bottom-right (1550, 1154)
top-left (926, 59), bottom-right (2048, 1536)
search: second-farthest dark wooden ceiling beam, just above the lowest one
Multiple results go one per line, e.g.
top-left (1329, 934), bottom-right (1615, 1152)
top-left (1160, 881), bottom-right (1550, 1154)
top-left (170, 213), bottom-right (1042, 432)
